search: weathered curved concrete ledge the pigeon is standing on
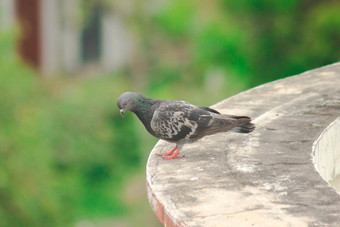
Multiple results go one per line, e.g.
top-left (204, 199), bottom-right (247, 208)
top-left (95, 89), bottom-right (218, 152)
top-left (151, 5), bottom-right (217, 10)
top-left (147, 63), bottom-right (340, 227)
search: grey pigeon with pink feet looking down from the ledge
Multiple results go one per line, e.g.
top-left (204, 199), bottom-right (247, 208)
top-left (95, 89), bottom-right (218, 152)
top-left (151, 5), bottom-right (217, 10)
top-left (117, 92), bottom-right (255, 160)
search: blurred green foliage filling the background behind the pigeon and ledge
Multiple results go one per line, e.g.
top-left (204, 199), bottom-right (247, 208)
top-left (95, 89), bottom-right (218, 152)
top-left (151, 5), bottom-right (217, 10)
top-left (0, 0), bottom-right (340, 226)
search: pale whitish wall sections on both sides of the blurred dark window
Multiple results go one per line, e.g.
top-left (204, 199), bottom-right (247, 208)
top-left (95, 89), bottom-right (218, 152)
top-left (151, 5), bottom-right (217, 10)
top-left (40, 0), bottom-right (132, 75)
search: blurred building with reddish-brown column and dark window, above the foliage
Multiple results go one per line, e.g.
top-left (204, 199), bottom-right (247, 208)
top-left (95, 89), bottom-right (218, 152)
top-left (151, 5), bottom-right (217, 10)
top-left (0, 0), bottom-right (132, 75)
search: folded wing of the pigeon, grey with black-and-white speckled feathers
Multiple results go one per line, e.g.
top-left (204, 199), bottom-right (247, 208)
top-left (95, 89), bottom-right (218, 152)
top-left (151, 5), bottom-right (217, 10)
top-left (150, 101), bottom-right (238, 142)
